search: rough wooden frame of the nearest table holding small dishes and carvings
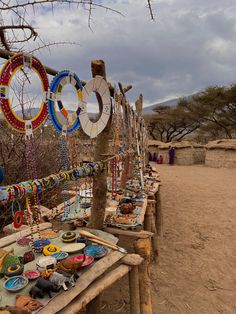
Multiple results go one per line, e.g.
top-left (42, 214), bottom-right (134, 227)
top-left (1, 223), bottom-right (144, 314)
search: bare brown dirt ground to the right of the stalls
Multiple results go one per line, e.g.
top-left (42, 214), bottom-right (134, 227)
top-left (152, 165), bottom-right (236, 314)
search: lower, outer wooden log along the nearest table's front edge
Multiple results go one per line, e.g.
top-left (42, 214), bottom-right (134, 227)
top-left (57, 265), bottom-right (130, 314)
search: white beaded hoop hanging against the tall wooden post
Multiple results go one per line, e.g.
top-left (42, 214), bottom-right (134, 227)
top-left (79, 75), bottom-right (111, 138)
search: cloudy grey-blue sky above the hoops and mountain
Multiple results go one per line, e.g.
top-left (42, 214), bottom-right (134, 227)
top-left (3, 0), bottom-right (236, 106)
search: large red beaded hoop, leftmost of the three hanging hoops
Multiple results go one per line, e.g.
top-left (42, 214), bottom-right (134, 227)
top-left (0, 53), bottom-right (49, 134)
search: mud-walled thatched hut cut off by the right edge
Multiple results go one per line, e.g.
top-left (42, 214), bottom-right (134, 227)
top-left (205, 139), bottom-right (236, 168)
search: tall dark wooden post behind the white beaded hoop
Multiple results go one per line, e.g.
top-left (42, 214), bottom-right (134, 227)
top-left (89, 60), bottom-right (111, 230)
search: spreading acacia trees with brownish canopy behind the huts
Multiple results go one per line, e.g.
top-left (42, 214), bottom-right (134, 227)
top-left (146, 84), bottom-right (236, 142)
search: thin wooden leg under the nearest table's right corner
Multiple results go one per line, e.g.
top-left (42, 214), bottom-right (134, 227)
top-left (129, 266), bottom-right (140, 314)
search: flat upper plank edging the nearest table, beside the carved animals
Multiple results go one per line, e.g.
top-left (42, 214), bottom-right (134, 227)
top-left (38, 251), bottom-right (124, 314)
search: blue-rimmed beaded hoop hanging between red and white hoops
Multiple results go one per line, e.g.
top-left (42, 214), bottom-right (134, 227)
top-left (47, 70), bottom-right (83, 134)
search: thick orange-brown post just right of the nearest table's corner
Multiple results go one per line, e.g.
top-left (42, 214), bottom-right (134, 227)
top-left (134, 237), bottom-right (152, 314)
